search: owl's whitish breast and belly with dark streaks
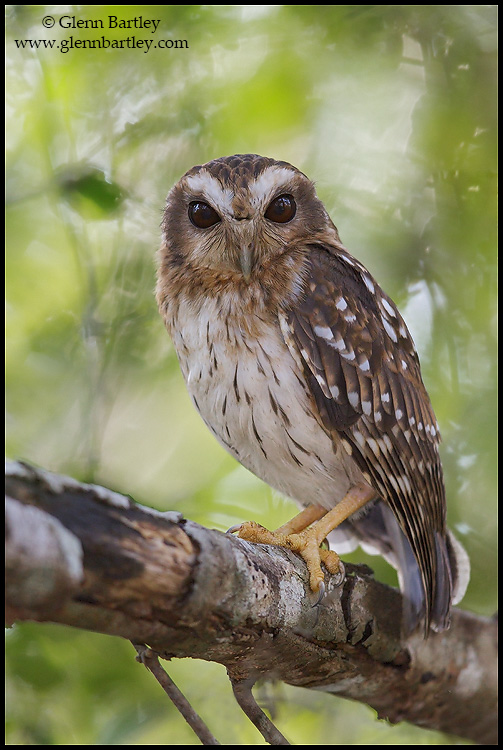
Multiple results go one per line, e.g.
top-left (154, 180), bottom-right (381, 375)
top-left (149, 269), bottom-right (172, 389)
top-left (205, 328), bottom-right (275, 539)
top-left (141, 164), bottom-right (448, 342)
top-left (171, 290), bottom-right (361, 508)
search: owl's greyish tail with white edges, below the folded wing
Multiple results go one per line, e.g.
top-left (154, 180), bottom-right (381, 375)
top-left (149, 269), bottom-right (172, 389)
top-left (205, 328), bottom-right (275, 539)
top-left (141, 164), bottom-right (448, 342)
top-left (330, 502), bottom-right (470, 637)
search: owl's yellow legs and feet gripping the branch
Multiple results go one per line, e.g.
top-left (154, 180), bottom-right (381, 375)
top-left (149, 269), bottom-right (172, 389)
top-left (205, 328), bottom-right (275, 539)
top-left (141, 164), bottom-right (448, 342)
top-left (229, 484), bottom-right (375, 594)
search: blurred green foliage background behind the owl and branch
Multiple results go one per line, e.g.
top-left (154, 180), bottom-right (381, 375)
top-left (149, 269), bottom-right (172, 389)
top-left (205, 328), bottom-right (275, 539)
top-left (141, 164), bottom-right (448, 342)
top-left (6, 5), bottom-right (497, 745)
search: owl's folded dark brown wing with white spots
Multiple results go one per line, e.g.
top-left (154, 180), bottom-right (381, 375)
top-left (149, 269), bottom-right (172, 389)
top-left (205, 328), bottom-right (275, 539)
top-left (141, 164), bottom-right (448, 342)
top-left (282, 245), bottom-right (452, 628)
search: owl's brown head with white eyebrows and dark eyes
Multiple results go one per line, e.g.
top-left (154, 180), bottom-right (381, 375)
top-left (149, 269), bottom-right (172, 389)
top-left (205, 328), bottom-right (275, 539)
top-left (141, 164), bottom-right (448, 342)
top-left (163, 154), bottom-right (338, 286)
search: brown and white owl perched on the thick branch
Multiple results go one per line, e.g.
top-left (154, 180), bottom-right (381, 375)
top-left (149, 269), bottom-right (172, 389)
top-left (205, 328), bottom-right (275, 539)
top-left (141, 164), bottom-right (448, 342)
top-left (156, 154), bottom-right (469, 637)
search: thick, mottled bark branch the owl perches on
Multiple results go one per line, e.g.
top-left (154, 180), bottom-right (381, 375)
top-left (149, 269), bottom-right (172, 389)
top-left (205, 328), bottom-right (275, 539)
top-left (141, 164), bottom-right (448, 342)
top-left (6, 463), bottom-right (497, 744)
